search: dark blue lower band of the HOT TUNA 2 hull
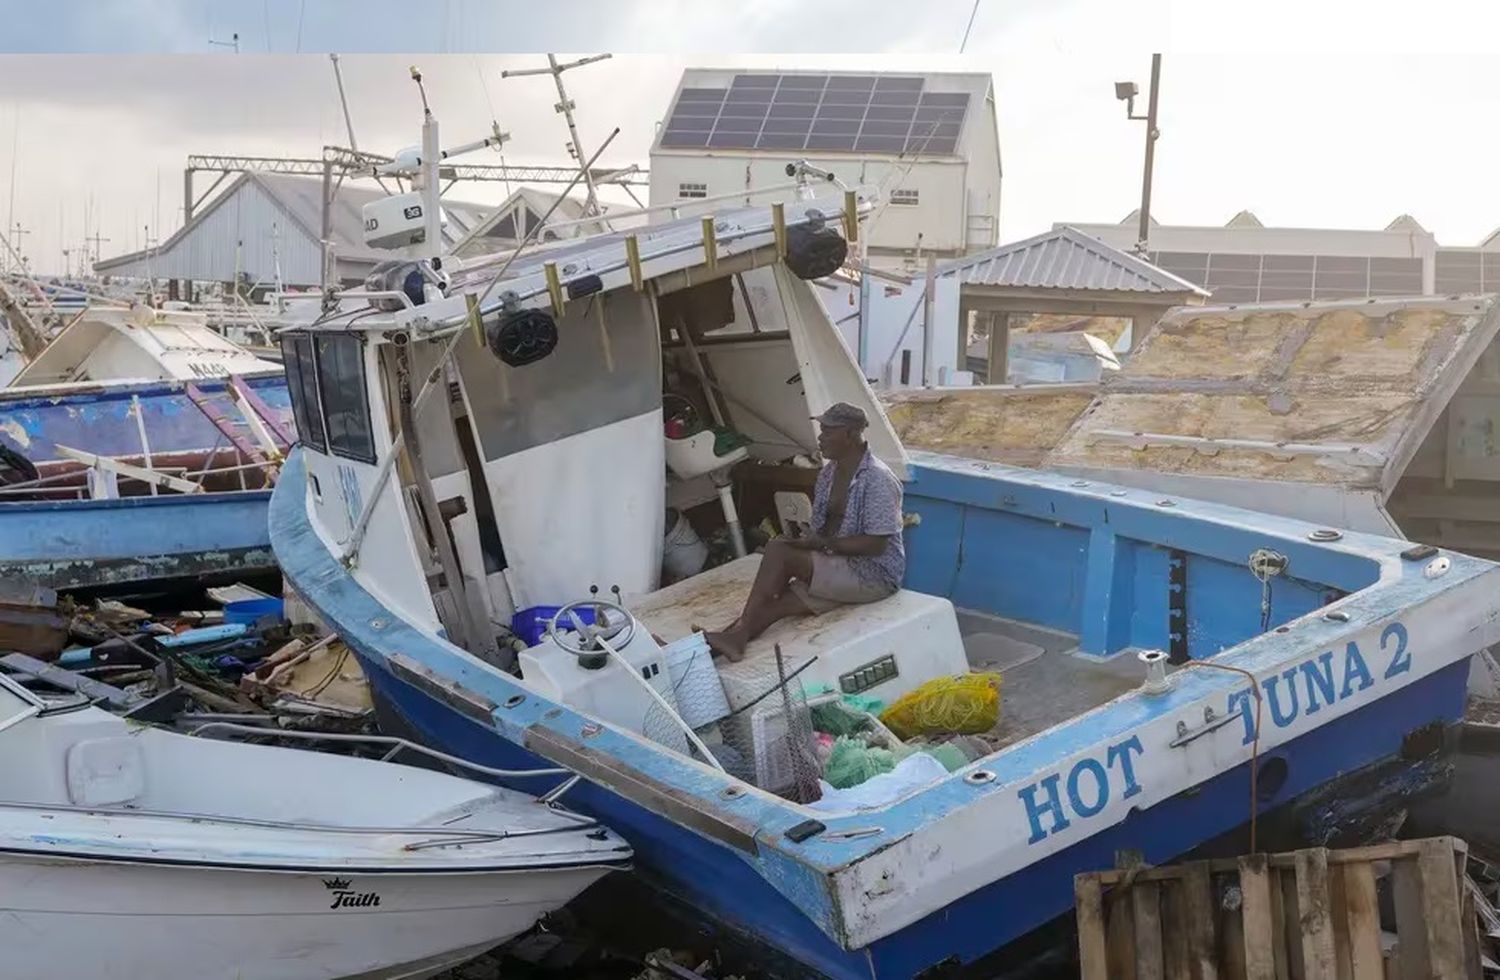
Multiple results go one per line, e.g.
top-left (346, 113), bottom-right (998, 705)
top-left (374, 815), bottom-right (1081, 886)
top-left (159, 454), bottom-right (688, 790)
top-left (356, 648), bottom-right (1469, 980)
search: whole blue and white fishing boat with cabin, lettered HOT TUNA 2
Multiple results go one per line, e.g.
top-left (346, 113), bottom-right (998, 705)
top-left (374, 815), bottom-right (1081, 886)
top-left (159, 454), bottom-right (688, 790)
top-left (270, 118), bottom-right (1500, 978)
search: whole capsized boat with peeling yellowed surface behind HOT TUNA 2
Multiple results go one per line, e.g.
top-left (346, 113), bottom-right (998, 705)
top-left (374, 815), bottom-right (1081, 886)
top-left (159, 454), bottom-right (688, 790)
top-left (884, 294), bottom-right (1500, 558)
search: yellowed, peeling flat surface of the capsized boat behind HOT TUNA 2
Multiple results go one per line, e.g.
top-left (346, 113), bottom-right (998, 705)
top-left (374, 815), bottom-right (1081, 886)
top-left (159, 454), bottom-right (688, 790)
top-left (888, 296), bottom-right (1500, 528)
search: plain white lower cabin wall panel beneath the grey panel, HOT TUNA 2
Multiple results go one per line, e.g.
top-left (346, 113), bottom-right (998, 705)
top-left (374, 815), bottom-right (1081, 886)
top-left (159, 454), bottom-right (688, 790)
top-left (485, 408), bottom-right (666, 609)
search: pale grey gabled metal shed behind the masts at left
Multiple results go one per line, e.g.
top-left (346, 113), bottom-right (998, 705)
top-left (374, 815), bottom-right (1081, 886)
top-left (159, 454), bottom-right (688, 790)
top-left (93, 173), bottom-right (494, 287)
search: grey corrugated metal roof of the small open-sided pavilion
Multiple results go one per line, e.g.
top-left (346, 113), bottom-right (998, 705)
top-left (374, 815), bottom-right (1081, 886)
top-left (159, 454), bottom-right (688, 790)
top-left (938, 228), bottom-right (1209, 297)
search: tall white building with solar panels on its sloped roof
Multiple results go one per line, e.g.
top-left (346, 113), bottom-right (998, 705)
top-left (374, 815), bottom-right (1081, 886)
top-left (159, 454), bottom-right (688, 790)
top-left (651, 68), bottom-right (1001, 269)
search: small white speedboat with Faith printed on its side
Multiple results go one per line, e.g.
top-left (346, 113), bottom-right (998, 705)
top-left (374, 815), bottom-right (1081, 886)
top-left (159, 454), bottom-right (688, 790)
top-left (0, 677), bottom-right (630, 980)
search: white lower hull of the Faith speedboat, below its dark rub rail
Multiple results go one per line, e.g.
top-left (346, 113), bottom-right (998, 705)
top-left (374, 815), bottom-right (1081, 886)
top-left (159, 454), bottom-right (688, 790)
top-left (0, 854), bottom-right (606, 980)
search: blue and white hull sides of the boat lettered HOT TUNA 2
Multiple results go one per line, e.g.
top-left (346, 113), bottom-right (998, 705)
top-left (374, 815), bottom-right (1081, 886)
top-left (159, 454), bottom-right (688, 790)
top-left (270, 459), bottom-right (1496, 978)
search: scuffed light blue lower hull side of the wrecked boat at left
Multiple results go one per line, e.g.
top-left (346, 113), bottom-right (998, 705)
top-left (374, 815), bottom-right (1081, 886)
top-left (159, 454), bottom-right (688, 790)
top-left (0, 491), bottom-right (276, 590)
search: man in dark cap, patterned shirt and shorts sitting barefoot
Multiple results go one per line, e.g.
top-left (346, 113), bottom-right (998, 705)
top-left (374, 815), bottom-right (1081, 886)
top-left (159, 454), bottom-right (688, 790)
top-left (705, 402), bottom-right (906, 660)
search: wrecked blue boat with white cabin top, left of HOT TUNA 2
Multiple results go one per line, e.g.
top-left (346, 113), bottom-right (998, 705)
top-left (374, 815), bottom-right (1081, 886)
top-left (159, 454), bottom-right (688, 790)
top-left (0, 306), bottom-right (291, 588)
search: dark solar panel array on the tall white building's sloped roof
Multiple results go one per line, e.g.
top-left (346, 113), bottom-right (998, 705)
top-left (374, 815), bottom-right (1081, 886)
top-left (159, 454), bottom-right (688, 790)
top-left (662, 75), bottom-right (969, 155)
